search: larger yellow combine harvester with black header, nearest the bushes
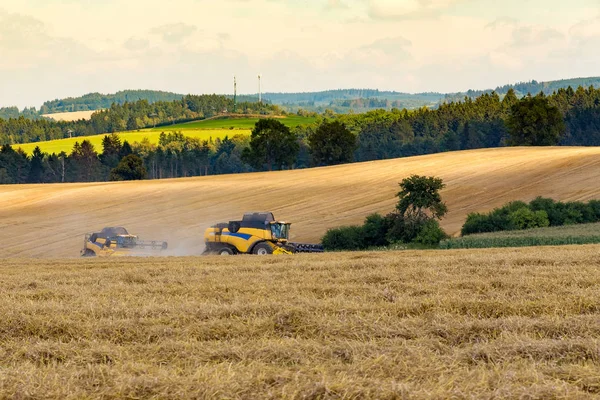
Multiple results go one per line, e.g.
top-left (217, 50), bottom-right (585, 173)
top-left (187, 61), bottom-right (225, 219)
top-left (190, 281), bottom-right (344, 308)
top-left (203, 212), bottom-right (323, 255)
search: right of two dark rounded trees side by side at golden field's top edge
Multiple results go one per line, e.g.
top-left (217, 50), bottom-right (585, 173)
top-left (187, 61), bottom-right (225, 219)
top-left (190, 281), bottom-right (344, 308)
top-left (308, 121), bottom-right (357, 165)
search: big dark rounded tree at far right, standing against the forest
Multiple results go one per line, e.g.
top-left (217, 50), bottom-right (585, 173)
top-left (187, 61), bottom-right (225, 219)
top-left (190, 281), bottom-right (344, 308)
top-left (507, 95), bottom-right (565, 146)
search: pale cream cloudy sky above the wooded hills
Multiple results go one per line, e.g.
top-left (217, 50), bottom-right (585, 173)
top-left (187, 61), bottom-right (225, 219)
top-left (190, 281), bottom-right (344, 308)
top-left (0, 0), bottom-right (600, 108)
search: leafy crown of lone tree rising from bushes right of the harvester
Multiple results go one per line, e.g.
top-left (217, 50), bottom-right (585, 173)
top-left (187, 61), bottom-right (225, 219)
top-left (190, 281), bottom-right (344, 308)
top-left (396, 175), bottom-right (448, 219)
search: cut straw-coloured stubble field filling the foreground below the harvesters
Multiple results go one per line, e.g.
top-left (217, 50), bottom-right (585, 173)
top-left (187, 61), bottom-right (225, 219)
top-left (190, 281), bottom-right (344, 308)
top-left (0, 245), bottom-right (600, 399)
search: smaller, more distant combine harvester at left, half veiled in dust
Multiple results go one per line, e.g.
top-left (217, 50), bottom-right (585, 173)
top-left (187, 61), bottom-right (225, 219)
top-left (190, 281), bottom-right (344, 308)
top-left (81, 227), bottom-right (168, 257)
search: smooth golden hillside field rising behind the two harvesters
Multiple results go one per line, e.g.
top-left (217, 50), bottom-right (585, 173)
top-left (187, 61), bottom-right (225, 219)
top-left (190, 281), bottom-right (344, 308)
top-left (0, 147), bottom-right (600, 257)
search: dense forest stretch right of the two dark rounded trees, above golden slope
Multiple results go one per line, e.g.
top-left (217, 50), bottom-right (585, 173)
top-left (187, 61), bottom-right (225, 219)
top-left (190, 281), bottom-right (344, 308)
top-left (328, 83), bottom-right (600, 161)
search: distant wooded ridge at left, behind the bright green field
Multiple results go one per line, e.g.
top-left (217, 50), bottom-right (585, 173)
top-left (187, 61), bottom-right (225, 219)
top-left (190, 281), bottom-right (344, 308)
top-left (0, 95), bottom-right (281, 144)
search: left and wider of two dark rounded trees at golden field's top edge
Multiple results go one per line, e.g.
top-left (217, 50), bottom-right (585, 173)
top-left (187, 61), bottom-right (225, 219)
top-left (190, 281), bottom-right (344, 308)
top-left (242, 118), bottom-right (300, 171)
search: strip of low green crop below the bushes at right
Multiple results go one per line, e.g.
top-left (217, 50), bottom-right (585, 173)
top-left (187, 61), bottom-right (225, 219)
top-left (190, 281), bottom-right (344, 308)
top-left (440, 223), bottom-right (600, 249)
